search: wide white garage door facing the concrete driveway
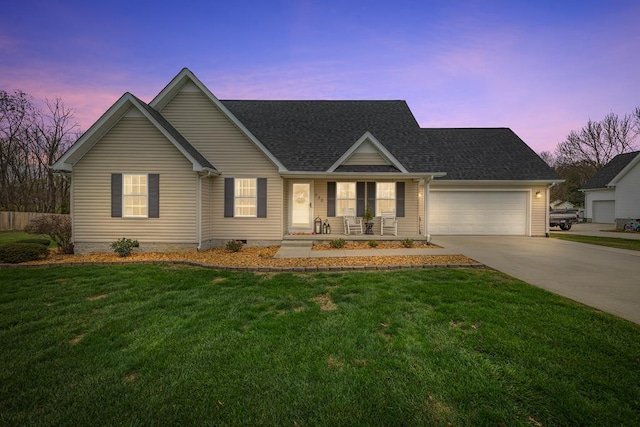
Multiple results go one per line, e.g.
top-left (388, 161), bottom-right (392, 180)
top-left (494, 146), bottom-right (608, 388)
top-left (429, 191), bottom-right (529, 236)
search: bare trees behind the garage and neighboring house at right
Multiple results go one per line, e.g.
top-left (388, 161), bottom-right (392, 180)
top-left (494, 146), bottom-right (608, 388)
top-left (540, 107), bottom-right (640, 206)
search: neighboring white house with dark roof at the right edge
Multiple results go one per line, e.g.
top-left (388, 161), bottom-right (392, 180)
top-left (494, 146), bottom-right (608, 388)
top-left (580, 151), bottom-right (640, 229)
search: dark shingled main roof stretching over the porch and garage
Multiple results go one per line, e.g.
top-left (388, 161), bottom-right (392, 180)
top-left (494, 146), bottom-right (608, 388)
top-left (221, 100), bottom-right (559, 180)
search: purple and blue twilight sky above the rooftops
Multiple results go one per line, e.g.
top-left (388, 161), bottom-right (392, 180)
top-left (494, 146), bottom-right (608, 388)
top-left (0, 0), bottom-right (640, 153)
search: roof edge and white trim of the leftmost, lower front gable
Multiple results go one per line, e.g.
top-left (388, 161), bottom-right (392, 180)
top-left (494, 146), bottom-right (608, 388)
top-left (52, 92), bottom-right (217, 173)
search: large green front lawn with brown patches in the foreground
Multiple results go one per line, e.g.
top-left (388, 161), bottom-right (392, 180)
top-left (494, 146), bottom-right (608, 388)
top-left (0, 265), bottom-right (640, 426)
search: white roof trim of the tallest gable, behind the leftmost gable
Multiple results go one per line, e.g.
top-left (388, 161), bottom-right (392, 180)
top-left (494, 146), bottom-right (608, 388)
top-left (149, 68), bottom-right (287, 171)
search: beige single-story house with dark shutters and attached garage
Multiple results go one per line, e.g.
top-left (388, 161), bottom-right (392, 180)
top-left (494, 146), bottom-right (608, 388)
top-left (52, 68), bottom-right (559, 253)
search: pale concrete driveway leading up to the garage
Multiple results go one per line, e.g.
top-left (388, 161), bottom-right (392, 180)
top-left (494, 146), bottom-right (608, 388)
top-left (432, 236), bottom-right (640, 324)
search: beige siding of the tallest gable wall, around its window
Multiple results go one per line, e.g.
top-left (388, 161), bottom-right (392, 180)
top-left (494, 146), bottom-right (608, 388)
top-left (161, 84), bottom-right (283, 245)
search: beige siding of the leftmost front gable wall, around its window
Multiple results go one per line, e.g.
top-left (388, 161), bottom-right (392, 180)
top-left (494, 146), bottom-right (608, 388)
top-left (72, 117), bottom-right (198, 253)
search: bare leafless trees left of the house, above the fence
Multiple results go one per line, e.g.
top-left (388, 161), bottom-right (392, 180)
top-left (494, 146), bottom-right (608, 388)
top-left (0, 90), bottom-right (80, 213)
